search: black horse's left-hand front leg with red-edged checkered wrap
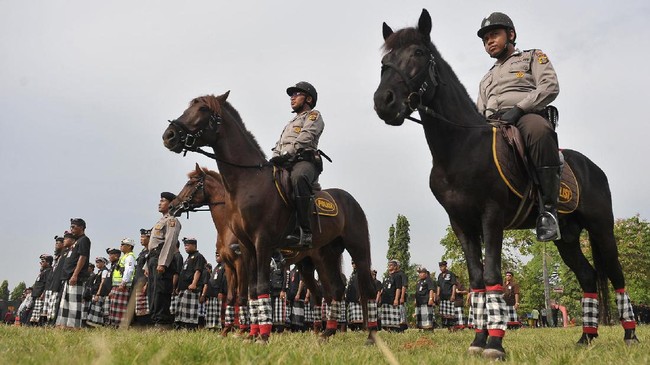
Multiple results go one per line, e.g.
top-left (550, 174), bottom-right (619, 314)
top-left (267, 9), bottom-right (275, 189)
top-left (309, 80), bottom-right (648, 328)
top-left (452, 221), bottom-right (488, 355)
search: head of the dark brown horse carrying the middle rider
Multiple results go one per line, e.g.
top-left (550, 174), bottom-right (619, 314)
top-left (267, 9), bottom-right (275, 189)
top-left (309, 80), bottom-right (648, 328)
top-left (163, 91), bottom-right (230, 153)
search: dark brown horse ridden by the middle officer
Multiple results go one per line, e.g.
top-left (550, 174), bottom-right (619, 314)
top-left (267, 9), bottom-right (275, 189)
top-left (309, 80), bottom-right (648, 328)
top-left (163, 92), bottom-right (376, 341)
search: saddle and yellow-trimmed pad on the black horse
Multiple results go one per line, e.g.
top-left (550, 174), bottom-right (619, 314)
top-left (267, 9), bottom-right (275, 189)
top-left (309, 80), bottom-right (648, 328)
top-left (491, 122), bottom-right (580, 228)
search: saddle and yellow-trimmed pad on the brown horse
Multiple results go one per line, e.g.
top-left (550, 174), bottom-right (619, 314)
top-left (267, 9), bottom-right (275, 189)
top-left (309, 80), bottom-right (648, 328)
top-left (273, 166), bottom-right (339, 217)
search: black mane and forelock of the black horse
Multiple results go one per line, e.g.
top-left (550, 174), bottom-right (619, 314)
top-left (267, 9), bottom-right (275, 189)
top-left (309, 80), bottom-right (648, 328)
top-left (382, 28), bottom-right (479, 114)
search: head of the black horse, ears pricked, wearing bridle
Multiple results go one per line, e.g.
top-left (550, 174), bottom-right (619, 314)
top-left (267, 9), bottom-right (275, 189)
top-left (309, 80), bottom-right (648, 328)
top-left (374, 9), bottom-right (438, 125)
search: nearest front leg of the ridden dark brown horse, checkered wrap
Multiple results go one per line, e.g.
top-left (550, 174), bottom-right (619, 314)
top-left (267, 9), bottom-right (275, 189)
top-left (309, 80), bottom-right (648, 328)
top-left (251, 237), bottom-right (273, 343)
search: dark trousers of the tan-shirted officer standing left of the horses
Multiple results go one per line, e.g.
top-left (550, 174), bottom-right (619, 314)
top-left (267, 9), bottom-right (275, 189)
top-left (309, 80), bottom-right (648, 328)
top-left (147, 250), bottom-right (174, 325)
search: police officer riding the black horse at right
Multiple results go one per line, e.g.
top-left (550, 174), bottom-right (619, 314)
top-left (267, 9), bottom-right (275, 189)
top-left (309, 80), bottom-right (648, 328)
top-left (477, 12), bottom-right (560, 241)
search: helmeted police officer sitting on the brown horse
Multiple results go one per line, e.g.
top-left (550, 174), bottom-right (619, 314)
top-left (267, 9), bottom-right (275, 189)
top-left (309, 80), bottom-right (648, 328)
top-left (271, 81), bottom-right (325, 248)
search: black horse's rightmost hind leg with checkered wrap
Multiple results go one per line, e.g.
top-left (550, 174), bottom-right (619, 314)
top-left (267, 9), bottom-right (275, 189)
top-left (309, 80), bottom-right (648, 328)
top-left (588, 222), bottom-right (638, 345)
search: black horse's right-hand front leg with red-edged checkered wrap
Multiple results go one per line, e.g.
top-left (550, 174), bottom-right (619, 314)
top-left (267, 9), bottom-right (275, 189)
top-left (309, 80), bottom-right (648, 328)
top-left (482, 218), bottom-right (508, 359)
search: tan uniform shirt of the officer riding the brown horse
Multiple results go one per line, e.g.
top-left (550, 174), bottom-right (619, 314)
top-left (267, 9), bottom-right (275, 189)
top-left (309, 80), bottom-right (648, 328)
top-left (273, 109), bottom-right (325, 156)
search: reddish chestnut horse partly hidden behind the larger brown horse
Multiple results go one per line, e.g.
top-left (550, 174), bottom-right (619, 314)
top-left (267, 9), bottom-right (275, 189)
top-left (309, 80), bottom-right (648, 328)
top-left (170, 164), bottom-right (345, 335)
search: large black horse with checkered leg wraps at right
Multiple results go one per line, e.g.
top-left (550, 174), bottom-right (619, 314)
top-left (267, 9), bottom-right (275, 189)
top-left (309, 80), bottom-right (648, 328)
top-left (374, 10), bottom-right (636, 358)
